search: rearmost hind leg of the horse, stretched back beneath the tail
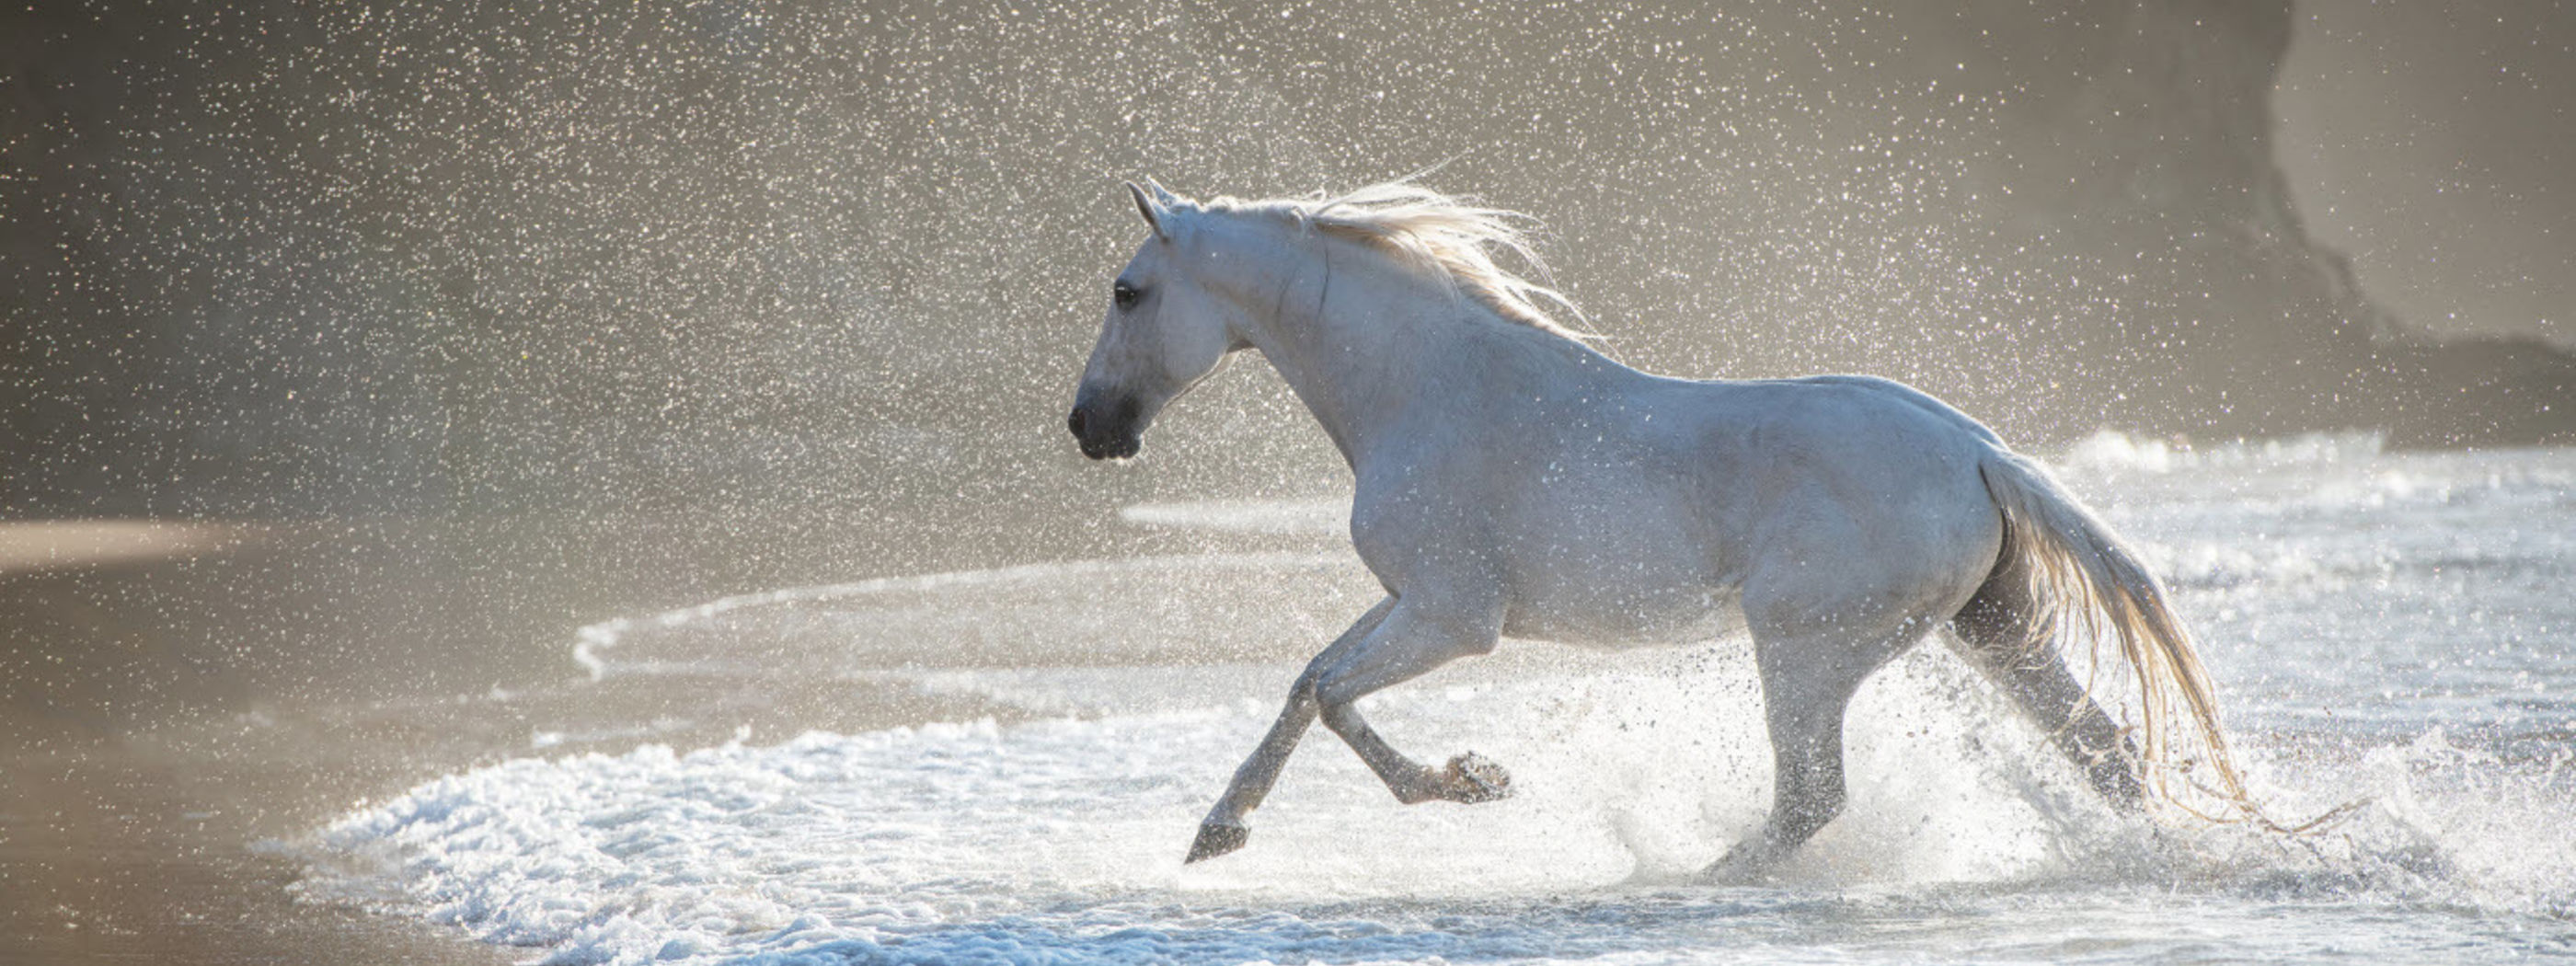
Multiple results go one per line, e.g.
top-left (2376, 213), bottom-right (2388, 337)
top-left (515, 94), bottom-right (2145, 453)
top-left (1950, 580), bottom-right (2145, 811)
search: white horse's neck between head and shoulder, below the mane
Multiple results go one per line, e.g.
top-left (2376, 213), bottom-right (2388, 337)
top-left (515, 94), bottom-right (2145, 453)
top-left (1221, 237), bottom-right (1597, 471)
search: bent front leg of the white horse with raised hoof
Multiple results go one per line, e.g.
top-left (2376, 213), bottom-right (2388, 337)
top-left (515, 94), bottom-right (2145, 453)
top-left (1308, 600), bottom-right (1512, 804)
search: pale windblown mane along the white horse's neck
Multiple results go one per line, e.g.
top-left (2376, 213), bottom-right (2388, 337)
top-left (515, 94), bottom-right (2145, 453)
top-left (1205, 178), bottom-right (1592, 340)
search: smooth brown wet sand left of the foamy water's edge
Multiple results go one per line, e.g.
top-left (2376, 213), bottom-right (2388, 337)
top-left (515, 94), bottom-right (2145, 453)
top-left (0, 505), bottom-right (1288, 963)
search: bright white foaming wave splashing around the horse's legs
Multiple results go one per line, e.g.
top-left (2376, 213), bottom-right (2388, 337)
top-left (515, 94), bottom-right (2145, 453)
top-left (299, 650), bottom-right (2576, 963)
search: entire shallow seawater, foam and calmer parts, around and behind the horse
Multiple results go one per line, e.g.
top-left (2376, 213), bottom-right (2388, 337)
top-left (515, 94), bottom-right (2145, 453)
top-left (292, 438), bottom-right (2576, 963)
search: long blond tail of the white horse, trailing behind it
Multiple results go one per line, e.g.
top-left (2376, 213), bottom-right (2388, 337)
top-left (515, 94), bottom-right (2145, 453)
top-left (1978, 451), bottom-right (2272, 827)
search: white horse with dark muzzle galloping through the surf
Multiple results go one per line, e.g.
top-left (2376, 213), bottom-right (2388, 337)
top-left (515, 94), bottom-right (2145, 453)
top-left (1069, 183), bottom-right (2244, 879)
